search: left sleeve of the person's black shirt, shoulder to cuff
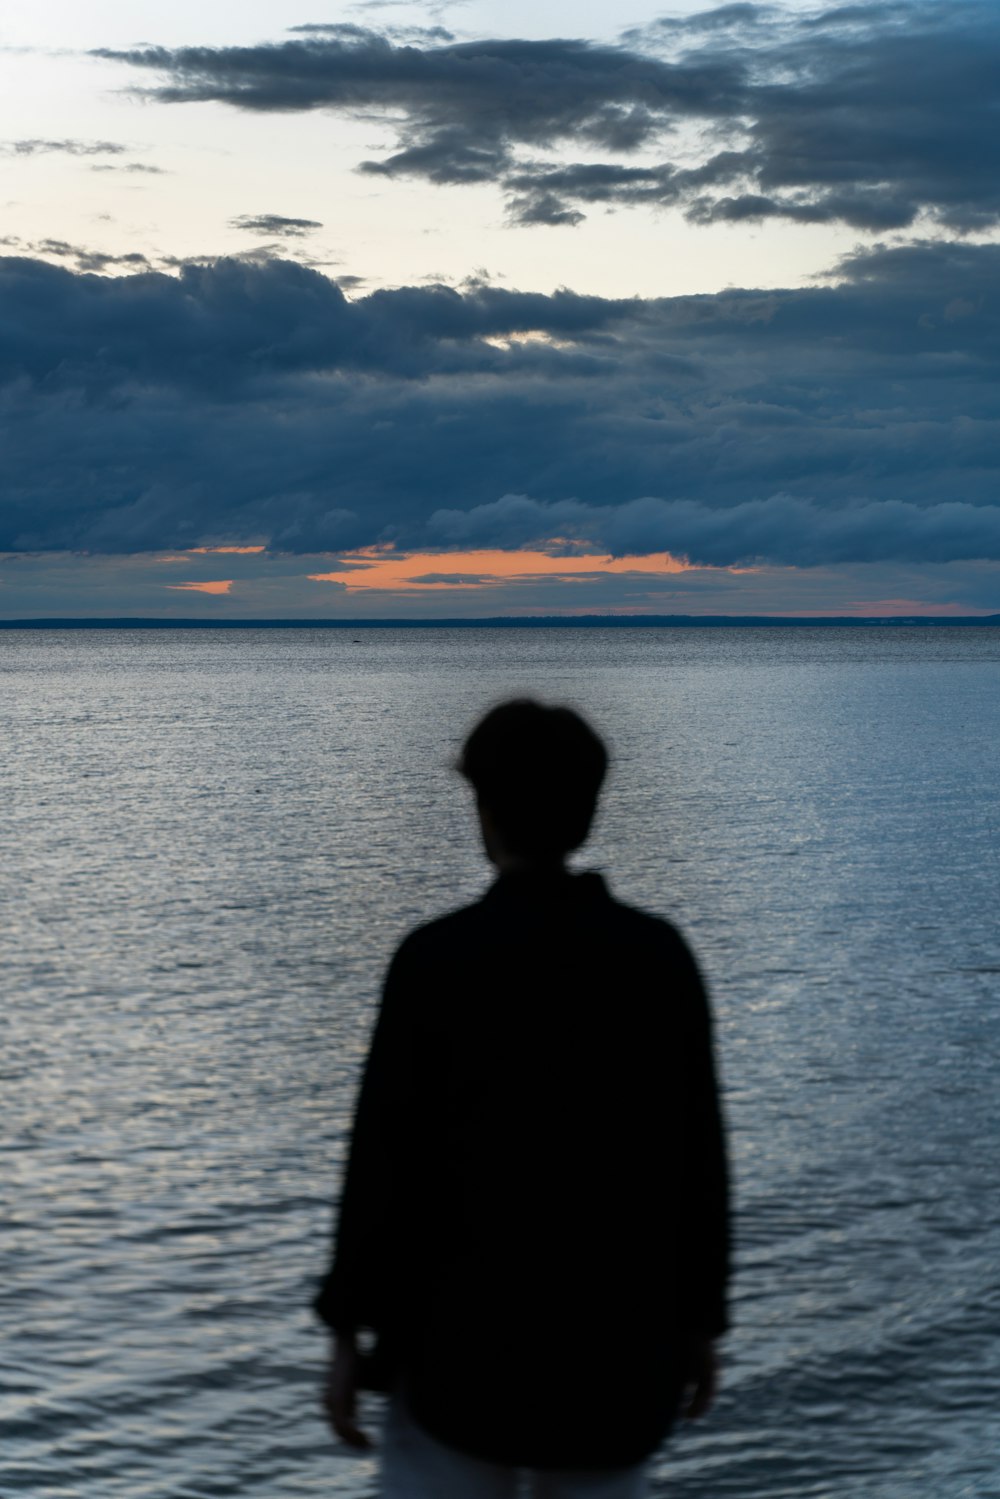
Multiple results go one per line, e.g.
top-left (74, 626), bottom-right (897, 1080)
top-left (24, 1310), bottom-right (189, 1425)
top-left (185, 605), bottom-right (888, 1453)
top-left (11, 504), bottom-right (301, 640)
top-left (313, 940), bottom-right (412, 1336)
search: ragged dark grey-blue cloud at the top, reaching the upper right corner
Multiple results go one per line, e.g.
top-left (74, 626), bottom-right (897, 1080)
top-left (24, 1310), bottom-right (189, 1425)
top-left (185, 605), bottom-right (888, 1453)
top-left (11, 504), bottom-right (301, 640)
top-left (99, 0), bottom-right (1000, 232)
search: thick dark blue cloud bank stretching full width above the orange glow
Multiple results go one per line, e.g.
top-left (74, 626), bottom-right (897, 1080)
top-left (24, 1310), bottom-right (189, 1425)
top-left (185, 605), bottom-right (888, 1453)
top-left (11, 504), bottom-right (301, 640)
top-left (0, 243), bottom-right (1000, 571)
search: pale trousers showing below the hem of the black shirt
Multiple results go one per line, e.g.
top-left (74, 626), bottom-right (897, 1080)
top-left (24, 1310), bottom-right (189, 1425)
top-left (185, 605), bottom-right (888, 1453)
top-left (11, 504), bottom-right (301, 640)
top-left (379, 1396), bottom-right (649, 1499)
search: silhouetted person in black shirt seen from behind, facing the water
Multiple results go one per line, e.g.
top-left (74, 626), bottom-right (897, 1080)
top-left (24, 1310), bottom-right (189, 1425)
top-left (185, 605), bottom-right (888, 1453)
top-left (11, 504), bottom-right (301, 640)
top-left (315, 702), bottom-right (727, 1499)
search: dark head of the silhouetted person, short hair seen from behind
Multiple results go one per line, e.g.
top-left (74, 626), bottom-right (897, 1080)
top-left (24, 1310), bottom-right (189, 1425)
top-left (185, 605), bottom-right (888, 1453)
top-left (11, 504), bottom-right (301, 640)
top-left (459, 699), bottom-right (607, 859)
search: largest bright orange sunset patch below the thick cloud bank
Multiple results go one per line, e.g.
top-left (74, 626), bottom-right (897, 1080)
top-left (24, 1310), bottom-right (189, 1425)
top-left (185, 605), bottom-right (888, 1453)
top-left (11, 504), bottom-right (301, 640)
top-left (309, 547), bottom-right (691, 592)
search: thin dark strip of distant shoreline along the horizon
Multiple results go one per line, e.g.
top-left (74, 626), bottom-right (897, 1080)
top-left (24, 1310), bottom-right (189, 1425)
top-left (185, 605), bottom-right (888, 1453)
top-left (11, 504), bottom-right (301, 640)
top-left (0, 615), bottom-right (1000, 630)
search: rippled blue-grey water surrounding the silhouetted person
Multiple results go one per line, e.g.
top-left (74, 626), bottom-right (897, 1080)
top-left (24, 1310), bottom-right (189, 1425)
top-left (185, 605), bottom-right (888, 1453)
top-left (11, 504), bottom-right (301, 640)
top-left (0, 627), bottom-right (1000, 1499)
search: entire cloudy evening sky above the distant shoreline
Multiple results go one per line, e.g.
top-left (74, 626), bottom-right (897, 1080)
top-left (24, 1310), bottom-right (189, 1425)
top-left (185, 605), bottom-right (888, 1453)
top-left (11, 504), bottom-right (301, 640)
top-left (0, 0), bottom-right (1000, 619)
